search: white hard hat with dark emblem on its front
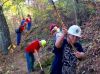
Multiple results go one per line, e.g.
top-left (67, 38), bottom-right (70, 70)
top-left (68, 25), bottom-right (81, 37)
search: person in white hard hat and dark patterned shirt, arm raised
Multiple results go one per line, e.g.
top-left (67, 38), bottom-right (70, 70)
top-left (55, 25), bottom-right (85, 74)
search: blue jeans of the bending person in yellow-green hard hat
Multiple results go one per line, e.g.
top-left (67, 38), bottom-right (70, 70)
top-left (25, 52), bottom-right (35, 73)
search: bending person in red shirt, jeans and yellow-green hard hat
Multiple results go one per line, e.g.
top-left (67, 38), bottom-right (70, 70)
top-left (25, 40), bottom-right (46, 74)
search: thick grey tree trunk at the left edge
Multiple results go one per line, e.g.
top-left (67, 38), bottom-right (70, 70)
top-left (0, 5), bottom-right (11, 54)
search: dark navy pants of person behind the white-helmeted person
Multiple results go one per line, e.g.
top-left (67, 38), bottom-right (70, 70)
top-left (50, 56), bottom-right (62, 74)
